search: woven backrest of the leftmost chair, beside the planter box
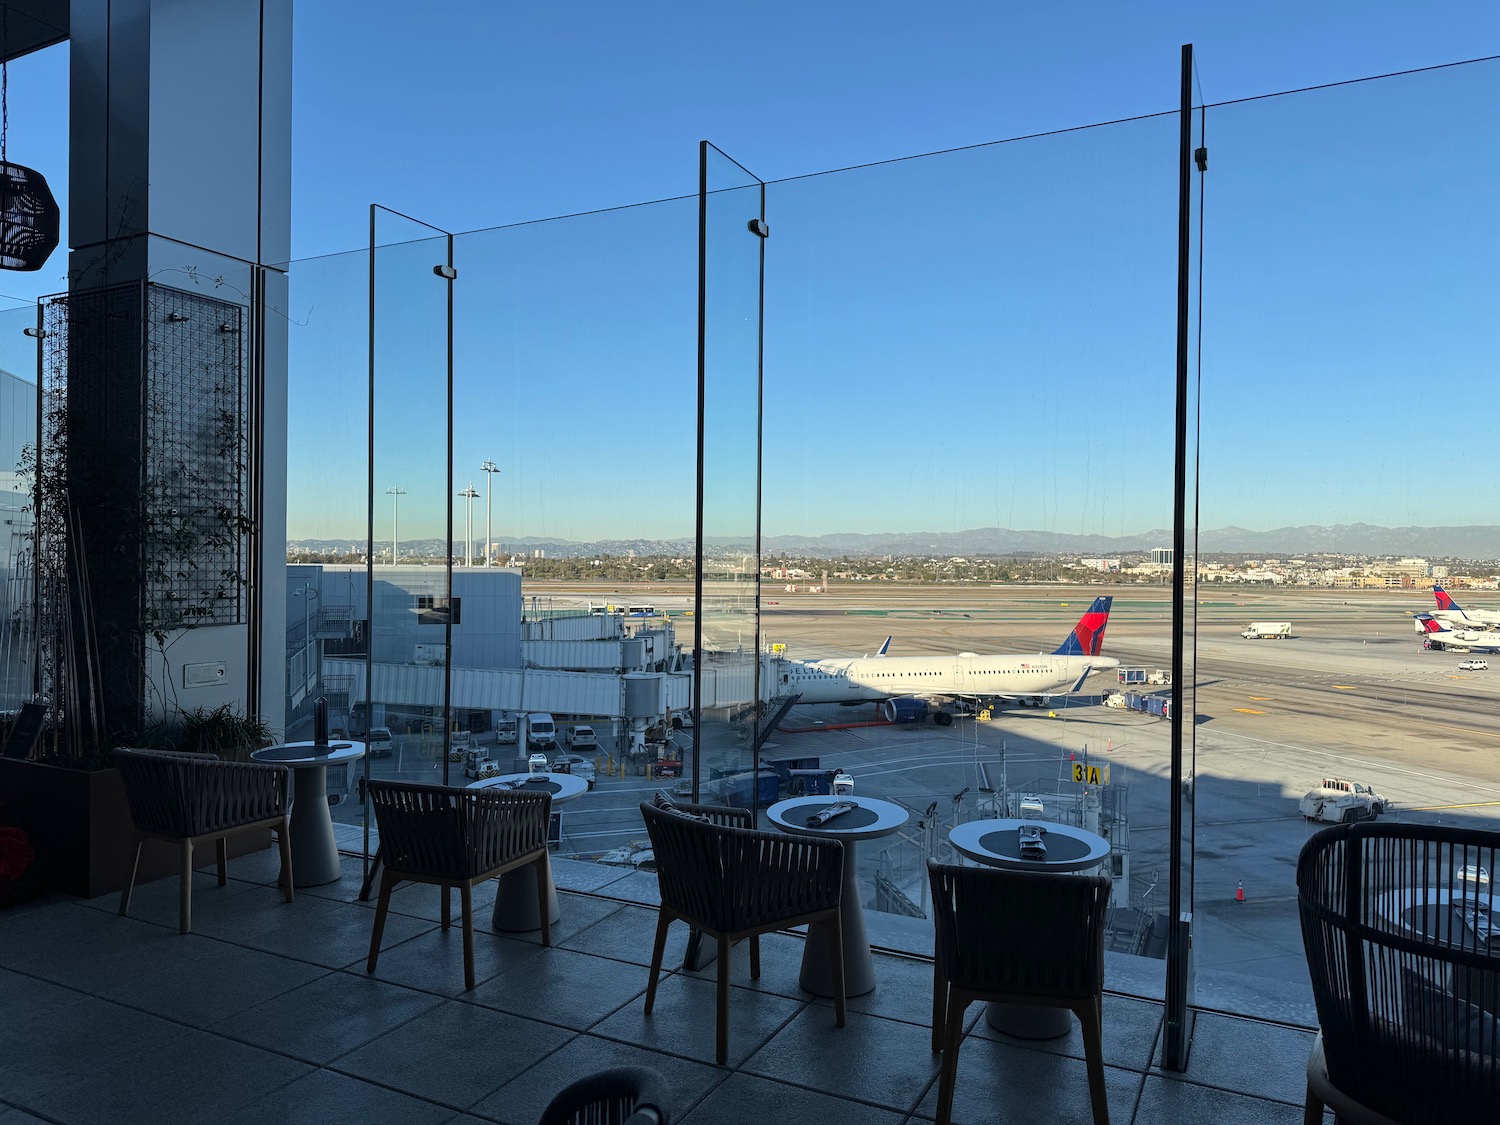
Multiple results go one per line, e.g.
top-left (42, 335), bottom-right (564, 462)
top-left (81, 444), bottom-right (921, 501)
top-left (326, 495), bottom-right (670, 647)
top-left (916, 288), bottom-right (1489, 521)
top-left (114, 747), bottom-right (290, 837)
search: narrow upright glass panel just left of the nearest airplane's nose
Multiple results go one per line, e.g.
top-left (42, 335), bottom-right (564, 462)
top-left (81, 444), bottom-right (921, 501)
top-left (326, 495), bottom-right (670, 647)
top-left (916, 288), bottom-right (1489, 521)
top-left (693, 141), bottom-right (762, 807)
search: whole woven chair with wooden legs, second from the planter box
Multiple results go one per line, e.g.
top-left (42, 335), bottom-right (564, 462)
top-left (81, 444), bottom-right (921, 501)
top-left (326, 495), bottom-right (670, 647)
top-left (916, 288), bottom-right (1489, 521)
top-left (365, 782), bottom-right (552, 989)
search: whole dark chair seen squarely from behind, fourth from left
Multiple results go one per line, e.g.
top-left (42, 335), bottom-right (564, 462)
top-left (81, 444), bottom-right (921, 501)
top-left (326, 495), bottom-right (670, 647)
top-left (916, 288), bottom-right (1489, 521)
top-left (927, 860), bottom-right (1110, 1125)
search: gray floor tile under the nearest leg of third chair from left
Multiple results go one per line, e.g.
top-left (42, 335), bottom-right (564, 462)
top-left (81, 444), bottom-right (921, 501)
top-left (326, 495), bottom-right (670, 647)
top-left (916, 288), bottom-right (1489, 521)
top-left (593, 975), bottom-right (810, 1067)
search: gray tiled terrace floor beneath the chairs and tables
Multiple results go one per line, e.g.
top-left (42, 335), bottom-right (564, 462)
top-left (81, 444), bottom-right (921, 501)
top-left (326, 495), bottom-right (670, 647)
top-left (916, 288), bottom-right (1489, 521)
top-left (0, 854), bottom-right (1332, 1125)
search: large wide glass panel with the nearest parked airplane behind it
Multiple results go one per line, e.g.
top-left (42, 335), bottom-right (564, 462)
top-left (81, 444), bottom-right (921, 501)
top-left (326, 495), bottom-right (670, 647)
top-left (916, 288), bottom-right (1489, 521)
top-left (762, 114), bottom-right (1179, 996)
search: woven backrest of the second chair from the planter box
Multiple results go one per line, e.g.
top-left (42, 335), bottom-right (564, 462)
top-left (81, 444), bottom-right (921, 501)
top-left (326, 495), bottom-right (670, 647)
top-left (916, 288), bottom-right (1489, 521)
top-left (369, 780), bottom-right (552, 879)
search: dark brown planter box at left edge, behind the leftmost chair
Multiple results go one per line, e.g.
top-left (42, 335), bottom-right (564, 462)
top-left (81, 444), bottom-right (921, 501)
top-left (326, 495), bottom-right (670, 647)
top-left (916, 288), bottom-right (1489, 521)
top-left (0, 759), bottom-right (272, 899)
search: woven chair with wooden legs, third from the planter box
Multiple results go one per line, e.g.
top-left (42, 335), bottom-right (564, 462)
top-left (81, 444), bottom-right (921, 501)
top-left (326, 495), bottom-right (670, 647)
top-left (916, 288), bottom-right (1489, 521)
top-left (641, 804), bottom-right (845, 1065)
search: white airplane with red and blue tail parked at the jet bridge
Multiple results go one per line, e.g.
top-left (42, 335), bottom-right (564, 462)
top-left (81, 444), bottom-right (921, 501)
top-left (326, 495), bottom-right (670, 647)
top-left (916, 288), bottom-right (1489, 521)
top-left (774, 597), bottom-right (1119, 726)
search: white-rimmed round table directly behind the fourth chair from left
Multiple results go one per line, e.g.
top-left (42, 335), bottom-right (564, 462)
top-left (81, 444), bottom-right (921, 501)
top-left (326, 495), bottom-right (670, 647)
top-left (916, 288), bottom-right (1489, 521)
top-left (948, 821), bottom-right (1110, 1040)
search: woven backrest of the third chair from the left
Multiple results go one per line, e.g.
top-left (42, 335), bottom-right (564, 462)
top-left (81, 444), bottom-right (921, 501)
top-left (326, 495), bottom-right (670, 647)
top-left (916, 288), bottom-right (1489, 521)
top-left (641, 803), bottom-right (845, 933)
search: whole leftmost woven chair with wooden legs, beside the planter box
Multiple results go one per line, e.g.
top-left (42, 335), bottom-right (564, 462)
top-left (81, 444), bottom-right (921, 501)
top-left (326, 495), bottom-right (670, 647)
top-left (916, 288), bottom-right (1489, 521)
top-left (114, 747), bottom-right (293, 933)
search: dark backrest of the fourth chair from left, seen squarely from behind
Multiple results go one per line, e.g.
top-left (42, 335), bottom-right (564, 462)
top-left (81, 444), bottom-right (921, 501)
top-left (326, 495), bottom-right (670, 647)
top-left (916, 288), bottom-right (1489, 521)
top-left (927, 860), bottom-right (1110, 999)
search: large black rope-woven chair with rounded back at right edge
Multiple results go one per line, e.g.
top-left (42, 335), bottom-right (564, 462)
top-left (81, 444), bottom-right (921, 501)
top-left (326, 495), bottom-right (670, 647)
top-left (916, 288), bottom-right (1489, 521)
top-left (1298, 824), bottom-right (1500, 1125)
